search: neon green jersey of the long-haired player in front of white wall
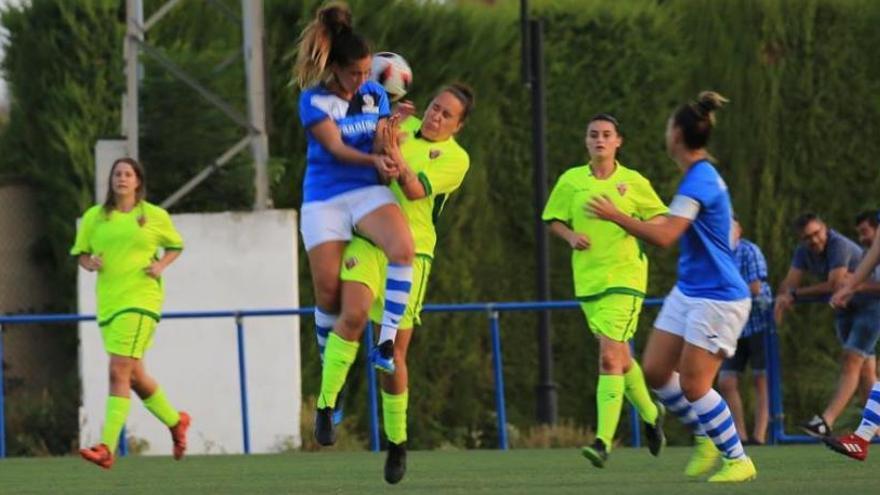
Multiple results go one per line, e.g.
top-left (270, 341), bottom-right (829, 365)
top-left (70, 201), bottom-right (183, 326)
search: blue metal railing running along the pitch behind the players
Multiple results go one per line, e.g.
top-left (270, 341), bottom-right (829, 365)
top-left (0, 298), bottom-right (856, 458)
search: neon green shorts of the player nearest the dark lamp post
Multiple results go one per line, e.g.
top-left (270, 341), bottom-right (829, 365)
top-left (581, 294), bottom-right (644, 342)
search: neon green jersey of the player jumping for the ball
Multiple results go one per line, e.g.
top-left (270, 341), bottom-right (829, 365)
top-left (391, 117), bottom-right (470, 257)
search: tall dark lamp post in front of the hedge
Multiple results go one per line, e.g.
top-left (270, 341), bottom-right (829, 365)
top-left (529, 19), bottom-right (557, 425)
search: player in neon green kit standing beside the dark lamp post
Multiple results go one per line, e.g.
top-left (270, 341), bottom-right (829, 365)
top-left (543, 114), bottom-right (667, 467)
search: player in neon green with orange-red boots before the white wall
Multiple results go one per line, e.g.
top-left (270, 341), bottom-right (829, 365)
top-left (70, 158), bottom-right (190, 469)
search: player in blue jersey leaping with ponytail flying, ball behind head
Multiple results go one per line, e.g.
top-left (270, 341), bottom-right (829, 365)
top-left (295, 2), bottom-right (414, 396)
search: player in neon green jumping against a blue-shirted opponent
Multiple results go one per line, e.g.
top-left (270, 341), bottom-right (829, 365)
top-left (316, 84), bottom-right (474, 484)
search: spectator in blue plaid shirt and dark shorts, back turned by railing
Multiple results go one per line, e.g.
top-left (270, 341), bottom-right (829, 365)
top-left (718, 218), bottom-right (773, 445)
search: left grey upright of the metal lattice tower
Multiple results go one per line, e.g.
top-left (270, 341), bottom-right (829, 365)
top-left (122, 0), bottom-right (144, 160)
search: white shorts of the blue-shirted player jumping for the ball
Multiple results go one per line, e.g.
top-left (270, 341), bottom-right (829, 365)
top-left (299, 186), bottom-right (397, 251)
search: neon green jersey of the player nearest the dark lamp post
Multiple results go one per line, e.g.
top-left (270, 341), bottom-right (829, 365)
top-left (542, 163), bottom-right (668, 299)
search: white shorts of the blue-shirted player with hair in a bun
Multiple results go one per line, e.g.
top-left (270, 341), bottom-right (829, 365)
top-left (654, 287), bottom-right (752, 357)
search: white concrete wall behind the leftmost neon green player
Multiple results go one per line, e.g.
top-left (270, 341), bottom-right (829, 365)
top-left (79, 210), bottom-right (301, 455)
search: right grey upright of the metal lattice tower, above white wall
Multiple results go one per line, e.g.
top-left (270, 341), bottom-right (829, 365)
top-left (241, 0), bottom-right (269, 210)
